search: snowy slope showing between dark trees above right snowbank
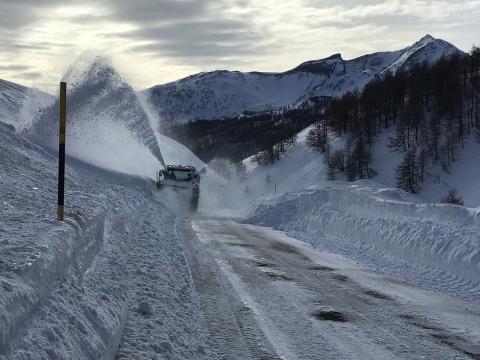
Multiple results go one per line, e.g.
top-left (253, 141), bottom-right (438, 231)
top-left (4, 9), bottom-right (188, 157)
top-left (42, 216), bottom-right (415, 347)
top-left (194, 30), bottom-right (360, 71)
top-left (243, 119), bottom-right (480, 208)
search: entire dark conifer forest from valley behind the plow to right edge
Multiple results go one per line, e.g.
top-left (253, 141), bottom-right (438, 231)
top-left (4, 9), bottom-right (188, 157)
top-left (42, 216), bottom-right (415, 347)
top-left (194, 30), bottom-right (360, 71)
top-left (162, 48), bottom-right (480, 203)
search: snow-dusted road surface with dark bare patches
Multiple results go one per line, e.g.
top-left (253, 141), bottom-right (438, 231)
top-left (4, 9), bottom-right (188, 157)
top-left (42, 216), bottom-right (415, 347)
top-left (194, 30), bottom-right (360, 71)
top-left (184, 217), bottom-right (480, 359)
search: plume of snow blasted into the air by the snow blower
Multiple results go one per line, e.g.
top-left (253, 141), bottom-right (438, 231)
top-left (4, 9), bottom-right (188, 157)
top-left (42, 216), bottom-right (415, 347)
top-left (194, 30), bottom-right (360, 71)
top-left (31, 58), bottom-right (163, 169)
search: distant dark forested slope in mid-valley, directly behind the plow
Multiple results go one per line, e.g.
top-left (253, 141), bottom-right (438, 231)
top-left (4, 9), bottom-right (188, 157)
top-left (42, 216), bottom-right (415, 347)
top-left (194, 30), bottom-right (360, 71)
top-left (161, 97), bottom-right (331, 164)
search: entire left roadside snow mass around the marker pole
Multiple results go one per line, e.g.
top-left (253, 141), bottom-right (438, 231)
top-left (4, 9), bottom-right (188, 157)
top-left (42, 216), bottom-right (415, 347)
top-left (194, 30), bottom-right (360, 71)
top-left (0, 123), bottom-right (209, 360)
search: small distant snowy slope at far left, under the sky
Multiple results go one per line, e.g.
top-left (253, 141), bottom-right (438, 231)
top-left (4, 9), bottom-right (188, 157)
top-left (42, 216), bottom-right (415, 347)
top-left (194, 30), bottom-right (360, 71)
top-left (0, 79), bottom-right (52, 129)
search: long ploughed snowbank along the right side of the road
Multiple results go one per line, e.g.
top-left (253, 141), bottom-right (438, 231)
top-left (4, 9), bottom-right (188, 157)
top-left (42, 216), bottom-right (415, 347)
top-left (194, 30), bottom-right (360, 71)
top-left (249, 181), bottom-right (480, 301)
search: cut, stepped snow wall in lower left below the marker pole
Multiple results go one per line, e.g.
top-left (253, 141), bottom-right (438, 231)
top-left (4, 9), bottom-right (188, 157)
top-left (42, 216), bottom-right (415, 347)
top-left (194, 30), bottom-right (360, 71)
top-left (0, 195), bottom-right (144, 359)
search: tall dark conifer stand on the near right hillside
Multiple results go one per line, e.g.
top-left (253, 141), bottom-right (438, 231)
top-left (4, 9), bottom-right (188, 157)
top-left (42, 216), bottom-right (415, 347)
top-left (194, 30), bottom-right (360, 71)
top-left (307, 48), bottom-right (480, 193)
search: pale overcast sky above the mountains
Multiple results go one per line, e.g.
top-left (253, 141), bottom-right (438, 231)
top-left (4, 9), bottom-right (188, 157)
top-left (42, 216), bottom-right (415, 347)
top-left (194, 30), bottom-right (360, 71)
top-left (0, 0), bottom-right (480, 91)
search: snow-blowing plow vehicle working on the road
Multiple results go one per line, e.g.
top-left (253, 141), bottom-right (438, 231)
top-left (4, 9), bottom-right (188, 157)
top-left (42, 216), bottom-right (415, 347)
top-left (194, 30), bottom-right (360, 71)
top-left (157, 165), bottom-right (200, 210)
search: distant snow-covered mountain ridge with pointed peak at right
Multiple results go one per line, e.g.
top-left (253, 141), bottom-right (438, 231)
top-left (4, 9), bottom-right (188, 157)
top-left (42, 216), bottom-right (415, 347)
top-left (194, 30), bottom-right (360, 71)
top-left (144, 35), bottom-right (463, 122)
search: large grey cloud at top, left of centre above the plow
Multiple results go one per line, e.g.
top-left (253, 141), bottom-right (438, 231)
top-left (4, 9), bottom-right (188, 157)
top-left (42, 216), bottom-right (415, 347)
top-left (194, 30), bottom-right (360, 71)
top-left (106, 0), bottom-right (268, 63)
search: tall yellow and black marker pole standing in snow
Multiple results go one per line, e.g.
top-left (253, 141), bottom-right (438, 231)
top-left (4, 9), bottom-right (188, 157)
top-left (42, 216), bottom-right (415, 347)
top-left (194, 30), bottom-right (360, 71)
top-left (57, 82), bottom-right (67, 221)
